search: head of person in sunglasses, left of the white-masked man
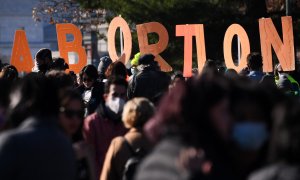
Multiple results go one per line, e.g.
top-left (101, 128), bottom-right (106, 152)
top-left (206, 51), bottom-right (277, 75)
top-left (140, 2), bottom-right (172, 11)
top-left (59, 90), bottom-right (84, 141)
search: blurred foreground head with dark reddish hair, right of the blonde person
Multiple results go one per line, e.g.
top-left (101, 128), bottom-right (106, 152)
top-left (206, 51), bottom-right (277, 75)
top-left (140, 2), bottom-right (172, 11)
top-left (145, 73), bottom-right (230, 147)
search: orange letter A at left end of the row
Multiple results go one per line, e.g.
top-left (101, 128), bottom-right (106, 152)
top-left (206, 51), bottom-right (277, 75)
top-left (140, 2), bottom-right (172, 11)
top-left (10, 30), bottom-right (34, 72)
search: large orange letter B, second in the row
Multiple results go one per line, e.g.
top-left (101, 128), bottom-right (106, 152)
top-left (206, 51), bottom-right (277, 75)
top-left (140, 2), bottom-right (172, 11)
top-left (56, 24), bottom-right (87, 73)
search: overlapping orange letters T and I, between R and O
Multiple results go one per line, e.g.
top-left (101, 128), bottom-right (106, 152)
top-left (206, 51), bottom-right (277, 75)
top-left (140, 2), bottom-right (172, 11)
top-left (176, 24), bottom-right (206, 77)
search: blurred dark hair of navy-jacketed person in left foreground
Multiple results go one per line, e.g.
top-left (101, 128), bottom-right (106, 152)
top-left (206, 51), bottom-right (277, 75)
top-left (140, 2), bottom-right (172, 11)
top-left (6, 73), bottom-right (59, 128)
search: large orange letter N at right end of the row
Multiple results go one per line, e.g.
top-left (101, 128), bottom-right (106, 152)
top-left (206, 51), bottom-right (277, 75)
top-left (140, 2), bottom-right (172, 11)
top-left (259, 16), bottom-right (295, 72)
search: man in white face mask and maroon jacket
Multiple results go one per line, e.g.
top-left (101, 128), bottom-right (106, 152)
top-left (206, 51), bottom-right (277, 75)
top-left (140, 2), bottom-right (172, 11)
top-left (83, 77), bottom-right (128, 179)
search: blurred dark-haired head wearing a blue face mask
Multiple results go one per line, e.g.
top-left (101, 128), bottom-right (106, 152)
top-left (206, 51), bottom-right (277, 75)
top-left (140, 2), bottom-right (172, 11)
top-left (231, 79), bottom-right (272, 152)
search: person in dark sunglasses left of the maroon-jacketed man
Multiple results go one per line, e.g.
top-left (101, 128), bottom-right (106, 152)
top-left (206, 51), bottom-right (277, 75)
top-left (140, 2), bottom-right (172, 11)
top-left (59, 89), bottom-right (96, 180)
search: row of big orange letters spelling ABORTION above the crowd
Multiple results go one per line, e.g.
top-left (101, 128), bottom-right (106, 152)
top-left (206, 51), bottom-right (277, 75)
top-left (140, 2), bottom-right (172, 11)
top-left (11, 16), bottom-right (295, 77)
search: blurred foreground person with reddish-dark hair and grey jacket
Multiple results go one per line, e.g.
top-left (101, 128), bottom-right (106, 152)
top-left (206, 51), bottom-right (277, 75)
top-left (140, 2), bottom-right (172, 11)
top-left (135, 71), bottom-right (235, 180)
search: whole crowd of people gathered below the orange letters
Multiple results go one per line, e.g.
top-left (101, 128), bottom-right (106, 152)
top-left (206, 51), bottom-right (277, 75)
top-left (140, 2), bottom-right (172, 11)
top-left (0, 49), bottom-right (300, 180)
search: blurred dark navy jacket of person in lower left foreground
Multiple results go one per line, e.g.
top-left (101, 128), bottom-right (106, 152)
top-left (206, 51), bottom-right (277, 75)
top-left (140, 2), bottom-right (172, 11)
top-left (0, 118), bottom-right (76, 180)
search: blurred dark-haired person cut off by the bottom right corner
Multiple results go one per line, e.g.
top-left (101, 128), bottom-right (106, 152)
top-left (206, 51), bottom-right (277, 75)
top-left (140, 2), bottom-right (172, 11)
top-left (248, 98), bottom-right (300, 180)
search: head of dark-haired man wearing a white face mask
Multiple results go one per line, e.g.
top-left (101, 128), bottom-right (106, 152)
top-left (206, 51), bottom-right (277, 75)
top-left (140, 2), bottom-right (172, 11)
top-left (104, 77), bottom-right (128, 115)
